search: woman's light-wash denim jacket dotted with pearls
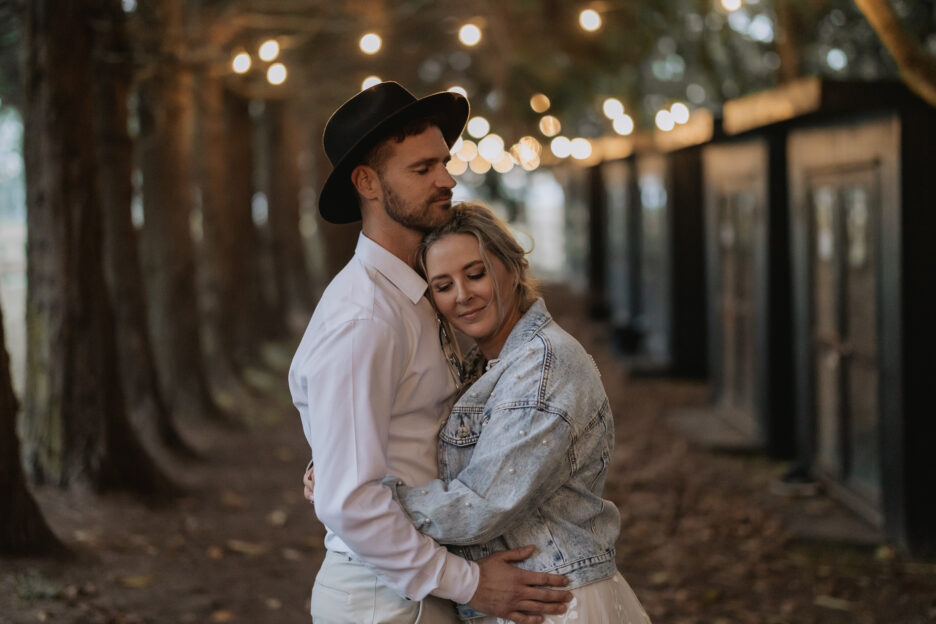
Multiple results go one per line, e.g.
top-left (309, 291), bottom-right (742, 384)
top-left (386, 299), bottom-right (620, 619)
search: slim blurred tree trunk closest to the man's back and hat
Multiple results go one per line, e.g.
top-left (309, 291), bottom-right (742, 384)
top-left (266, 100), bottom-right (314, 328)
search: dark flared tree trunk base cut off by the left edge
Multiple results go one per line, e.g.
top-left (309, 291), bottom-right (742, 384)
top-left (0, 298), bottom-right (64, 555)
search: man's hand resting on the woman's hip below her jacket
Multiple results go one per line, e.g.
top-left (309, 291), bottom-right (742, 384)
top-left (468, 546), bottom-right (572, 624)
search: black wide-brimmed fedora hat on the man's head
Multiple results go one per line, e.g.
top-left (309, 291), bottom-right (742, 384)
top-left (319, 82), bottom-right (468, 223)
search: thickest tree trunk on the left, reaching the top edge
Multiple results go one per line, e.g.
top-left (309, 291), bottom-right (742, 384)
top-left (23, 0), bottom-right (171, 493)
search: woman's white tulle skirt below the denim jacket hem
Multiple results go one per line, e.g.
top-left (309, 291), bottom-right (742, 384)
top-left (476, 572), bottom-right (650, 624)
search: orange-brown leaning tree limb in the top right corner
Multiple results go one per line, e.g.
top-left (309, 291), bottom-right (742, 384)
top-left (855, 0), bottom-right (936, 106)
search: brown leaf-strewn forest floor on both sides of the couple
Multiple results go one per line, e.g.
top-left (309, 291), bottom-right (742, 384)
top-left (0, 288), bottom-right (936, 624)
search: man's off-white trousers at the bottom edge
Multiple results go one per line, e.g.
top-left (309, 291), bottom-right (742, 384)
top-left (311, 550), bottom-right (459, 624)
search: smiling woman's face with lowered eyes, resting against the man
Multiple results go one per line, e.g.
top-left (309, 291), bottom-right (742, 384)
top-left (426, 234), bottom-right (519, 358)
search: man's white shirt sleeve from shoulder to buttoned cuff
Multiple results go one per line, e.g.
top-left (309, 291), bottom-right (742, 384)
top-left (290, 318), bottom-right (480, 603)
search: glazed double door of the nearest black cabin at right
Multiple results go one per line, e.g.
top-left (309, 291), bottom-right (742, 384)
top-left (809, 165), bottom-right (881, 524)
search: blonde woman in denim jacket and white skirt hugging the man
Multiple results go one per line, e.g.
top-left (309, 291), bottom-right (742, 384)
top-left (385, 204), bottom-right (649, 624)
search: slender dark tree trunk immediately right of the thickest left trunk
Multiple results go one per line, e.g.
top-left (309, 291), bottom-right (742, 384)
top-left (94, 0), bottom-right (194, 456)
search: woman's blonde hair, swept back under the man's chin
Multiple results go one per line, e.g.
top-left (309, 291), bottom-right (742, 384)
top-left (416, 202), bottom-right (539, 321)
